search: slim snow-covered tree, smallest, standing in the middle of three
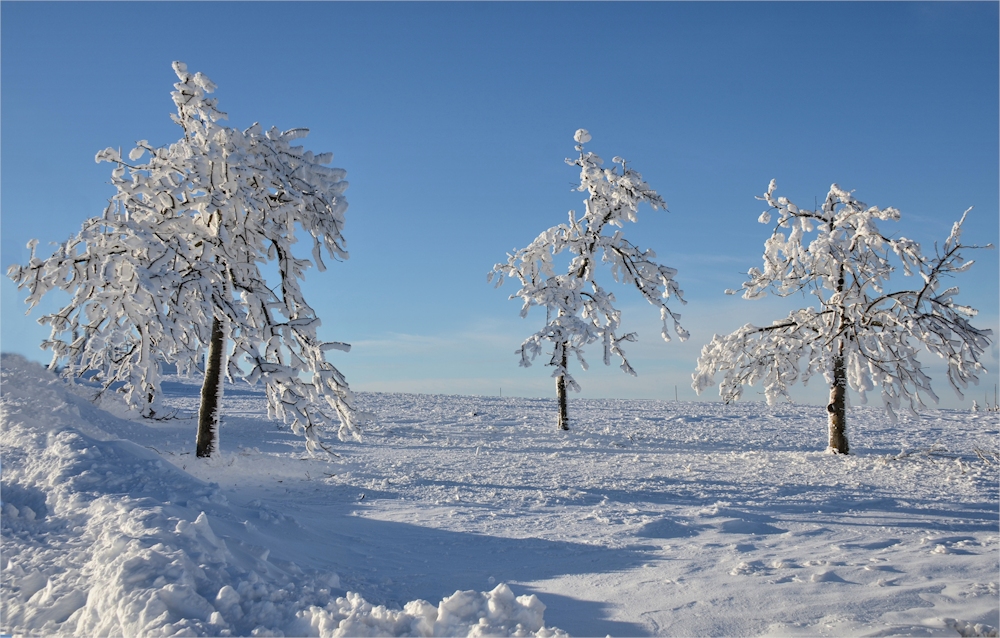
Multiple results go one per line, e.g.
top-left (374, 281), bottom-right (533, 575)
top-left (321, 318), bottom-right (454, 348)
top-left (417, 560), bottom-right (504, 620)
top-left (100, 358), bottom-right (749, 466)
top-left (487, 129), bottom-right (688, 430)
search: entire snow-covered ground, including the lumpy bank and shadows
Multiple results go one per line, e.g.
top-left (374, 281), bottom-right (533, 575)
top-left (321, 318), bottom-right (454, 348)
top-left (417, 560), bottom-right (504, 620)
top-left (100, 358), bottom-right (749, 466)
top-left (0, 356), bottom-right (1000, 636)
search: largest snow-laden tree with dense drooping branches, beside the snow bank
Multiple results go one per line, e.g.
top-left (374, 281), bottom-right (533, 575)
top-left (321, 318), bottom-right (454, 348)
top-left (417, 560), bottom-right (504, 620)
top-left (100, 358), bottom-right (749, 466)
top-left (8, 62), bottom-right (357, 456)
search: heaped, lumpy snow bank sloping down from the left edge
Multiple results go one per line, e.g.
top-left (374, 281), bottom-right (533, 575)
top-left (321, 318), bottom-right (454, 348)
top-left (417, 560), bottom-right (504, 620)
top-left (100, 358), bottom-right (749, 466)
top-left (0, 355), bottom-right (565, 636)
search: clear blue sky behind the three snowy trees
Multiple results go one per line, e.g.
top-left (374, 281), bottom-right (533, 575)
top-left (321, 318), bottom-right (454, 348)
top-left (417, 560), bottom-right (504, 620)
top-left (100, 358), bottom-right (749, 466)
top-left (0, 2), bottom-right (1000, 407)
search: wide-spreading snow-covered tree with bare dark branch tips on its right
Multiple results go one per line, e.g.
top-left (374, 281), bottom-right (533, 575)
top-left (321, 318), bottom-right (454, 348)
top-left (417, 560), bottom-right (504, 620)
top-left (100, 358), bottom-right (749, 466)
top-left (692, 180), bottom-right (992, 454)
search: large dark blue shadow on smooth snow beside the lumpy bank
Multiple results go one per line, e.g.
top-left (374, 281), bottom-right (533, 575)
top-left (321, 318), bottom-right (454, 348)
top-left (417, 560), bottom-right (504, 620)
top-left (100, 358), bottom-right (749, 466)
top-left (218, 510), bottom-right (655, 635)
